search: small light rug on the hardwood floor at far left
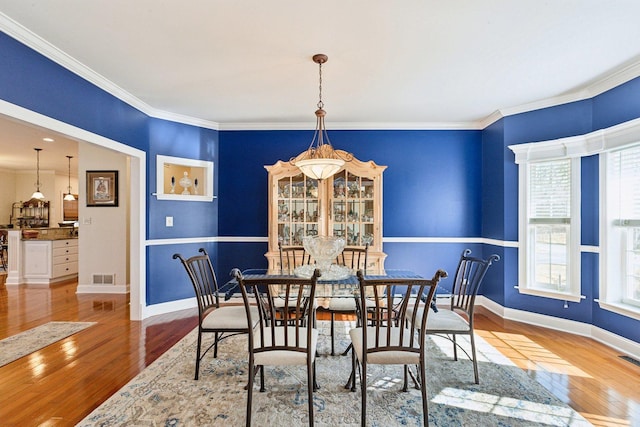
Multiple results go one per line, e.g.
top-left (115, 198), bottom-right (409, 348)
top-left (0, 322), bottom-right (95, 366)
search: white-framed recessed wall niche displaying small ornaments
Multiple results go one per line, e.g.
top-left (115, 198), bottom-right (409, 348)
top-left (154, 155), bottom-right (215, 202)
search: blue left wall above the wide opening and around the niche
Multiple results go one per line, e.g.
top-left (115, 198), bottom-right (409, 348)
top-left (0, 32), bottom-right (218, 304)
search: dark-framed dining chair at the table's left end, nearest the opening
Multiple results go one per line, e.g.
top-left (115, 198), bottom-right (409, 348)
top-left (173, 248), bottom-right (257, 380)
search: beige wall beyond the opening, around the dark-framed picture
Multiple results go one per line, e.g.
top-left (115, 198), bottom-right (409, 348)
top-left (78, 144), bottom-right (129, 293)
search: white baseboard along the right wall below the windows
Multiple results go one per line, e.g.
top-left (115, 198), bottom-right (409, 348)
top-left (476, 295), bottom-right (640, 360)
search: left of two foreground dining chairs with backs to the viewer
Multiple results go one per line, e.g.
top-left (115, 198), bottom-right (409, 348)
top-left (232, 269), bottom-right (320, 426)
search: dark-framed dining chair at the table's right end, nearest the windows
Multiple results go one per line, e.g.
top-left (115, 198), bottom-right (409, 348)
top-left (416, 249), bottom-right (500, 384)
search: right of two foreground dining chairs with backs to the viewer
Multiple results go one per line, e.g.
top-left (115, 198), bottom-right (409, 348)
top-left (349, 270), bottom-right (447, 426)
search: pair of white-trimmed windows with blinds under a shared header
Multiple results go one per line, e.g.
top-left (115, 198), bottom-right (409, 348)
top-left (509, 118), bottom-right (640, 320)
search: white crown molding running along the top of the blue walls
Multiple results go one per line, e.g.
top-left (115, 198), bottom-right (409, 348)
top-left (0, 12), bottom-right (640, 130)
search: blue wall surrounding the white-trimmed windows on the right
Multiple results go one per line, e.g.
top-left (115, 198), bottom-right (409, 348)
top-left (483, 84), bottom-right (640, 342)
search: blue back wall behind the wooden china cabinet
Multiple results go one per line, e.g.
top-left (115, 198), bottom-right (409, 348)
top-left (218, 130), bottom-right (482, 286)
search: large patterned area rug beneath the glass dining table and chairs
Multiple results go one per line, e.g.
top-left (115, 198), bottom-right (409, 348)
top-left (78, 322), bottom-right (591, 427)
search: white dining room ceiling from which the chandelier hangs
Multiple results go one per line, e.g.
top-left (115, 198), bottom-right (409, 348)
top-left (0, 0), bottom-right (640, 170)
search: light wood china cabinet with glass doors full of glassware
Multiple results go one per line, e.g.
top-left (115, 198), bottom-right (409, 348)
top-left (265, 150), bottom-right (386, 273)
